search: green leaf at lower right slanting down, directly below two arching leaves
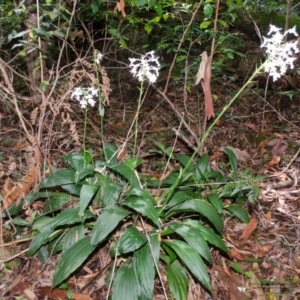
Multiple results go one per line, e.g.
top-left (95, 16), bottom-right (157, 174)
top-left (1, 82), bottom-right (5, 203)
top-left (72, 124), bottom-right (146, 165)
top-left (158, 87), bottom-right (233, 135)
top-left (164, 240), bottom-right (211, 291)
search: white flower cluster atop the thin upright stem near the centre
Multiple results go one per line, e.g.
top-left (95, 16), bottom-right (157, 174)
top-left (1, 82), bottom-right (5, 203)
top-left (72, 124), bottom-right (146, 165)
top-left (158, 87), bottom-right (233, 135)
top-left (129, 51), bottom-right (160, 83)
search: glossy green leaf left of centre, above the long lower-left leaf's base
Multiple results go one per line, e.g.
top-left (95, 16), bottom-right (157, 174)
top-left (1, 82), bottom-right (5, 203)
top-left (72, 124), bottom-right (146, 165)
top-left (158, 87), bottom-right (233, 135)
top-left (91, 205), bottom-right (130, 246)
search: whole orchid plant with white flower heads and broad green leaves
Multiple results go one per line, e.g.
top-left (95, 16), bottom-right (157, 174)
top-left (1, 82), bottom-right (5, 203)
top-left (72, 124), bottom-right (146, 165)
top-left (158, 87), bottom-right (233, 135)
top-left (38, 26), bottom-right (299, 300)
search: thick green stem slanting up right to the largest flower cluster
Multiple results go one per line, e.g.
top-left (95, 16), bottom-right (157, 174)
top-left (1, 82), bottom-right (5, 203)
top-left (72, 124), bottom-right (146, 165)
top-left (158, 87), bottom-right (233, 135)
top-left (158, 63), bottom-right (265, 211)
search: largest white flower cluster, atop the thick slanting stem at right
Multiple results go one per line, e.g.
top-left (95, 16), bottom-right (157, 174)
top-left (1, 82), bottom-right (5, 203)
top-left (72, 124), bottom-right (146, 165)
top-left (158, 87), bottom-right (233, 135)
top-left (261, 25), bottom-right (299, 81)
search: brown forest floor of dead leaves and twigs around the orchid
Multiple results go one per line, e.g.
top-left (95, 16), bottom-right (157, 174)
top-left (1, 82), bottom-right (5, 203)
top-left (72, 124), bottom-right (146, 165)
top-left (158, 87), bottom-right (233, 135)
top-left (0, 71), bottom-right (300, 300)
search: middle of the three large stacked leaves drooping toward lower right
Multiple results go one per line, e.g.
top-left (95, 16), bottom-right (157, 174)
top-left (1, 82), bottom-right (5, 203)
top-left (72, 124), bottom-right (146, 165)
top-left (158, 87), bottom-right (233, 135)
top-left (169, 222), bottom-right (211, 263)
